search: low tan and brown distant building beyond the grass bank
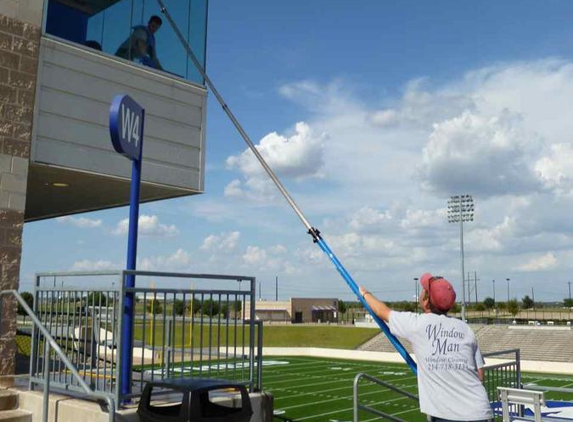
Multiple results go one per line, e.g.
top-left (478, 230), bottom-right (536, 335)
top-left (245, 298), bottom-right (339, 324)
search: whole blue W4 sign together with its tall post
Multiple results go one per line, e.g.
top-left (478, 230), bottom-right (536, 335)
top-left (109, 95), bottom-right (145, 395)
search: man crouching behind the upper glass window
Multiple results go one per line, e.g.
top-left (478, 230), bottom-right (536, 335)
top-left (115, 15), bottom-right (163, 70)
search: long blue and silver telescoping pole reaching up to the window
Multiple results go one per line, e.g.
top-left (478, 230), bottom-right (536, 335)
top-left (157, 0), bottom-right (418, 375)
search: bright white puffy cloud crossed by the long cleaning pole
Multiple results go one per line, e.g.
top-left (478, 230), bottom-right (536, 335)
top-left (225, 122), bottom-right (325, 199)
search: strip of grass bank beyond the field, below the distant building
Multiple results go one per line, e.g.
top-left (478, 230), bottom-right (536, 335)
top-left (134, 321), bottom-right (380, 349)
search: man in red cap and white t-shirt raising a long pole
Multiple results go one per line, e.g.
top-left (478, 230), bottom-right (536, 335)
top-left (360, 273), bottom-right (493, 422)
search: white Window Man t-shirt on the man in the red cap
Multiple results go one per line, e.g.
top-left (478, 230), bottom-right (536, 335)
top-left (388, 311), bottom-right (493, 421)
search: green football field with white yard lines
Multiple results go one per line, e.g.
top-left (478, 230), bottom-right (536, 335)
top-left (140, 357), bottom-right (573, 422)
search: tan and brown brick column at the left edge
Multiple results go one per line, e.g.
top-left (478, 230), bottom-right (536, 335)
top-left (0, 12), bottom-right (40, 375)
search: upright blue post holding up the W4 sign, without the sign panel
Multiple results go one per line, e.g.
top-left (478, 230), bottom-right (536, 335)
top-left (121, 110), bottom-right (145, 396)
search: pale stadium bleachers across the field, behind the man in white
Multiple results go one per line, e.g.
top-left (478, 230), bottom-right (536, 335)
top-left (358, 325), bottom-right (573, 362)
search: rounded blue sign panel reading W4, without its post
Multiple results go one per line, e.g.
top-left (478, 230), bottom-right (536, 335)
top-left (109, 95), bottom-right (145, 161)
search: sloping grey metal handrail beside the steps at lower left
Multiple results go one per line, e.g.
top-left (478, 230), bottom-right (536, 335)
top-left (0, 290), bottom-right (115, 422)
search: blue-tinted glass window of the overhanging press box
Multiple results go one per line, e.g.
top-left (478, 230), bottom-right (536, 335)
top-left (45, 0), bottom-right (208, 84)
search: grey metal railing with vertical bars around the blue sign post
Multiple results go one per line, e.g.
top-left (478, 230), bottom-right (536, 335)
top-left (30, 271), bottom-right (262, 403)
